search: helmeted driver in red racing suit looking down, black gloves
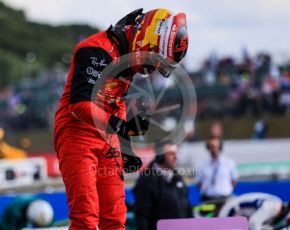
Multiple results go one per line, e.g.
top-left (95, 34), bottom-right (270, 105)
top-left (54, 9), bottom-right (188, 230)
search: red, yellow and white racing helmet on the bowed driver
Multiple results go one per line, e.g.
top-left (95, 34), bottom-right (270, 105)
top-left (131, 9), bottom-right (188, 77)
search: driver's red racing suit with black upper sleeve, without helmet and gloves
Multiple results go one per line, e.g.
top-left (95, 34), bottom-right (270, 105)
top-left (54, 31), bottom-right (129, 230)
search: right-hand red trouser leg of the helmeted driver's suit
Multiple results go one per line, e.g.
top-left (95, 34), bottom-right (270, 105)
top-left (97, 134), bottom-right (126, 230)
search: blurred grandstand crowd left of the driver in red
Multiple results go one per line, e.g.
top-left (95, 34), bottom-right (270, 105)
top-left (0, 69), bottom-right (67, 130)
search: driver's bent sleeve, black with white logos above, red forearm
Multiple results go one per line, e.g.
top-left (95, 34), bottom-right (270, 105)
top-left (69, 47), bottom-right (112, 126)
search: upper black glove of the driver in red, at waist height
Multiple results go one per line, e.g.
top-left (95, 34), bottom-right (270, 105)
top-left (107, 113), bottom-right (150, 136)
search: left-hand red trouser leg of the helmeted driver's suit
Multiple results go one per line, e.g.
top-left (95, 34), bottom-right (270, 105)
top-left (58, 127), bottom-right (99, 230)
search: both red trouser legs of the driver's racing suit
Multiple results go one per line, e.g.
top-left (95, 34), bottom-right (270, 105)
top-left (56, 123), bottom-right (126, 230)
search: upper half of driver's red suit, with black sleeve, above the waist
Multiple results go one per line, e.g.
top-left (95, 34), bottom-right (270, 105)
top-left (55, 31), bottom-right (128, 131)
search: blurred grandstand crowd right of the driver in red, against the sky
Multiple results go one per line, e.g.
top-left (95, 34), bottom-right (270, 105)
top-left (191, 50), bottom-right (290, 118)
